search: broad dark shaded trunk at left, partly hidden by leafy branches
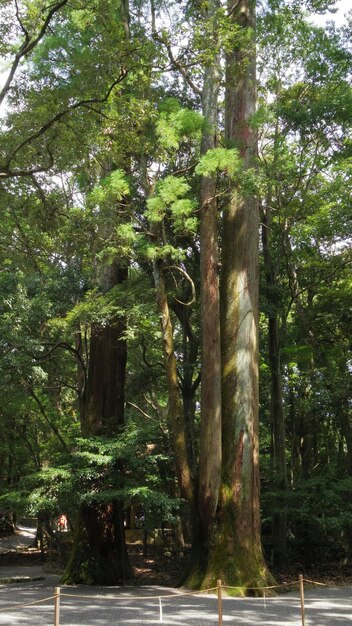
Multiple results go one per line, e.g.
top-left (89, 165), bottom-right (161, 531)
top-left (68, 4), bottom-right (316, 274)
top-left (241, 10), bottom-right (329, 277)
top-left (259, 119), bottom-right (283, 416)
top-left (62, 263), bottom-right (132, 585)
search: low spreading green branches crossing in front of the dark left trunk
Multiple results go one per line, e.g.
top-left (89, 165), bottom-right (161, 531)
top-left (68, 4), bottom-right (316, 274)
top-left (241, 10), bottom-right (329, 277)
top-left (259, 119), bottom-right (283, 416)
top-left (0, 422), bottom-right (179, 525)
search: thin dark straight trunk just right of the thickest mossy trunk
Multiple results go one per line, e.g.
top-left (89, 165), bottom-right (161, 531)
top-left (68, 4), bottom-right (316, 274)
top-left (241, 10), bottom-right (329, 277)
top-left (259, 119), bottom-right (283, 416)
top-left (261, 205), bottom-right (288, 568)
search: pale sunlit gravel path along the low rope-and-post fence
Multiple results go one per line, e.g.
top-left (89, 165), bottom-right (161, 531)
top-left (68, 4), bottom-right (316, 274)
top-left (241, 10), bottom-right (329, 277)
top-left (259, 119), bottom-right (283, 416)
top-left (0, 536), bottom-right (352, 626)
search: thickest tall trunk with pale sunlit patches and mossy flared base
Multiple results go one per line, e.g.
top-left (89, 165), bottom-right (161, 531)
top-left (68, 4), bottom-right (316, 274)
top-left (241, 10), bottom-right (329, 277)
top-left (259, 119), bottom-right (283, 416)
top-left (203, 0), bottom-right (270, 593)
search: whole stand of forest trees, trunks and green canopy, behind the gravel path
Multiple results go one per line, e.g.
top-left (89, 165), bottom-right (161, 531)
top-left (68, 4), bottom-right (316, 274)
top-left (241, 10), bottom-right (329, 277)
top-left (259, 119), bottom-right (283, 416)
top-left (0, 0), bottom-right (352, 587)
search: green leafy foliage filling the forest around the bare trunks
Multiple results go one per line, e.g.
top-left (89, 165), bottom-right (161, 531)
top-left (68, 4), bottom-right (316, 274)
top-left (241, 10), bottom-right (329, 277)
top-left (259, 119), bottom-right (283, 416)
top-left (0, 0), bottom-right (352, 576)
